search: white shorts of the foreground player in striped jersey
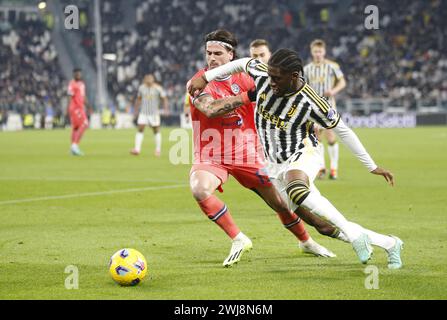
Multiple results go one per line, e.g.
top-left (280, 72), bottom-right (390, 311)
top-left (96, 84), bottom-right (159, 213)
top-left (266, 139), bottom-right (321, 211)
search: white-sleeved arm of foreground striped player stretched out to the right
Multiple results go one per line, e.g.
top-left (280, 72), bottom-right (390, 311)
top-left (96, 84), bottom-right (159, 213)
top-left (333, 119), bottom-right (394, 186)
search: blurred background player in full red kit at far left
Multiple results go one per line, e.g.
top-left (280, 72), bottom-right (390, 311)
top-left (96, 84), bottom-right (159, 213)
top-left (68, 68), bottom-right (88, 156)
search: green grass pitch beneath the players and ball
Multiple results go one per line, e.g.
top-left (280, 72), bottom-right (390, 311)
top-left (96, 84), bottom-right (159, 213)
top-left (0, 127), bottom-right (447, 300)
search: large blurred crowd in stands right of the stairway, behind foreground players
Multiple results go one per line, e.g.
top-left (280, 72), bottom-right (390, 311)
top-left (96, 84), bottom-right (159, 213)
top-left (78, 0), bottom-right (447, 114)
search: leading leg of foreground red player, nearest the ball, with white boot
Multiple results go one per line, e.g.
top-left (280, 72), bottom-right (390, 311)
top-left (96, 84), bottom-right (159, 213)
top-left (189, 170), bottom-right (253, 267)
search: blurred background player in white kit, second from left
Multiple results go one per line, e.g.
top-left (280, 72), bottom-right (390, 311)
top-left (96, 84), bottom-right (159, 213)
top-left (130, 74), bottom-right (169, 157)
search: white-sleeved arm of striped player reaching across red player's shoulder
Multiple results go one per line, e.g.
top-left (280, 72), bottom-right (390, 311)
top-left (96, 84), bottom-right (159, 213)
top-left (188, 58), bottom-right (252, 97)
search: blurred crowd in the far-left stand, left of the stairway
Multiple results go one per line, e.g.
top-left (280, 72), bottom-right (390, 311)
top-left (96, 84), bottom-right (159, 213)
top-left (0, 14), bottom-right (66, 125)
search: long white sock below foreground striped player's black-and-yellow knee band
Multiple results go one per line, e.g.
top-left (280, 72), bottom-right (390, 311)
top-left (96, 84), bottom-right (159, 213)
top-left (302, 191), bottom-right (362, 242)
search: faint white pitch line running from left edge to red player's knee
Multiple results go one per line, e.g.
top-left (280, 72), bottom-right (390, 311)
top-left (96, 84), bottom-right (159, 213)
top-left (0, 184), bottom-right (187, 205)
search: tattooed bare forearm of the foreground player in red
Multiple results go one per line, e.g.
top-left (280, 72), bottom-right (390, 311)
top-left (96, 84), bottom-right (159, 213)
top-left (194, 95), bottom-right (245, 118)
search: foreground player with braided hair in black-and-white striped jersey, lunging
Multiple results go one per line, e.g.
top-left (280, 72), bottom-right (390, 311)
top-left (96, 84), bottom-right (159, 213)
top-left (189, 49), bottom-right (403, 269)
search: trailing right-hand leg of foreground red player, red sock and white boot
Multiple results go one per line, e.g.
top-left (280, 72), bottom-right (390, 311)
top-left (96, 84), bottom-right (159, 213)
top-left (254, 186), bottom-right (336, 258)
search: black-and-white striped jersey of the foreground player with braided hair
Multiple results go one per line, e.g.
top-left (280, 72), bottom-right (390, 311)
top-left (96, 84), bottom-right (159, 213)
top-left (245, 59), bottom-right (340, 163)
